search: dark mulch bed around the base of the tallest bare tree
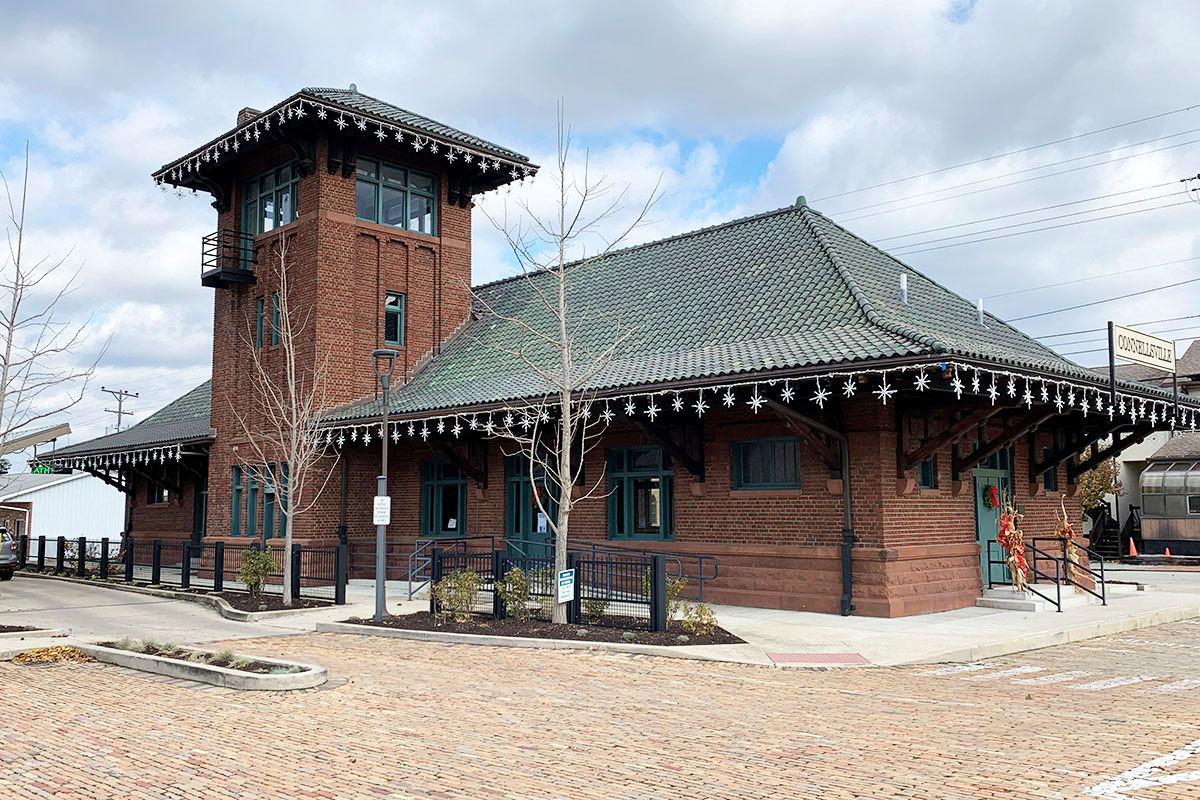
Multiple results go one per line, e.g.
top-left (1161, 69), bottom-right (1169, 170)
top-left (346, 612), bottom-right (743, 646)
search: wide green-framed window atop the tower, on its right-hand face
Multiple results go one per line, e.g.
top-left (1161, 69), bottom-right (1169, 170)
top-left (354, 158), bottom-right (438, 236)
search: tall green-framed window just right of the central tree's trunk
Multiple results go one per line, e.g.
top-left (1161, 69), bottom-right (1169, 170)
top-left (606, 446), bottom-right (674, 540)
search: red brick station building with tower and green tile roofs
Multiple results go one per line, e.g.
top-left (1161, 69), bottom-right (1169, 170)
top-left (39, 86), bottom-right (1198, 616)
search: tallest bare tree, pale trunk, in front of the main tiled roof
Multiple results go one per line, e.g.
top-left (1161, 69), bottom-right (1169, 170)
top-left (475, 104), bottom-right (659, 622)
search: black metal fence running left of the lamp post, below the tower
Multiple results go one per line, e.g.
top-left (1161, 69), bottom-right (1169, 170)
top-left (17, 536), bottom-right (348, 604)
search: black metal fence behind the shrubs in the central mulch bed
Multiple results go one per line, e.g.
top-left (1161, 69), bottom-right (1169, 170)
top-left (430, 547), bottom-right (667, 631)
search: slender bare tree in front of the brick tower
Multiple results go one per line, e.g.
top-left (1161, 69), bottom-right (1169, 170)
top-left (229, 236), bottom-right (337, 606)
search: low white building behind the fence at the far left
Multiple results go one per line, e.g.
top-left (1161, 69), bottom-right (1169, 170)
top-left (0, 473), bottom-right (125, 553)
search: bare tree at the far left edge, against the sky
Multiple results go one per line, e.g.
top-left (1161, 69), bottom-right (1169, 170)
top-left (0, 143), bottom-right (108, 455)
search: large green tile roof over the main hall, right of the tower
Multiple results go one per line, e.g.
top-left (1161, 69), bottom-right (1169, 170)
top-left (329, 206), bottom-right (1180, 421)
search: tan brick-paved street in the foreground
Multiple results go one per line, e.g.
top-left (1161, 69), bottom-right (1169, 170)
top-left (0, 622), bottom-right (1200, 800)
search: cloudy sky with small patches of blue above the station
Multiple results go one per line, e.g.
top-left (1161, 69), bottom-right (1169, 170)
top-left (0, 0), bottom-right (1200, 455)
